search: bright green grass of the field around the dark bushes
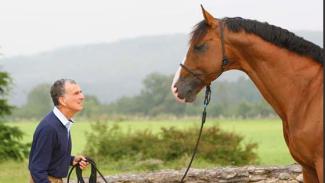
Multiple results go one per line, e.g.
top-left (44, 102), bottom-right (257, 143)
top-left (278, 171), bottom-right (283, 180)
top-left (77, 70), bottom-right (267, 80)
top-left (0, 118), bottom-right (295, 183)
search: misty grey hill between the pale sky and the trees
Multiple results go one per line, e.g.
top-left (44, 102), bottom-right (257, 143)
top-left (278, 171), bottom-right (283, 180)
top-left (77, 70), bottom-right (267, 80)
top-left (0, 31), bottom-right (323, 105)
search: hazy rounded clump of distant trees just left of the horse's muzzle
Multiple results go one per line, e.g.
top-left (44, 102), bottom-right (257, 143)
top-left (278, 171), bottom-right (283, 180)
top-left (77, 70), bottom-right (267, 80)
top-left (107, 73), bottom-right (187, 116)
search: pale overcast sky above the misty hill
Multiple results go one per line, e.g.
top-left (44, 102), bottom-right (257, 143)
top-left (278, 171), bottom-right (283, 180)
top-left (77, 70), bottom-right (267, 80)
top-left (0, 0), bottom-right (323, 57)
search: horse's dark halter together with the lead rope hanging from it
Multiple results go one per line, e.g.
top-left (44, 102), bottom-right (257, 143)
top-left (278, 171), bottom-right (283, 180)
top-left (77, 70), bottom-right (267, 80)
top-left (180, 20), bottom-right (229, 183)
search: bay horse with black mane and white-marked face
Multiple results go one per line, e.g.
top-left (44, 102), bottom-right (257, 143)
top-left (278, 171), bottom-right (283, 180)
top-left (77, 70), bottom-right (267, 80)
top-left (171, 7), bottom-right (323, 183)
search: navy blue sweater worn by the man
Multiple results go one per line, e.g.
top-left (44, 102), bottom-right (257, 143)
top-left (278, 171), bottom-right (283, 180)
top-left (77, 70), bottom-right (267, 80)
top-left (28, 111), bottom-right (73, 183)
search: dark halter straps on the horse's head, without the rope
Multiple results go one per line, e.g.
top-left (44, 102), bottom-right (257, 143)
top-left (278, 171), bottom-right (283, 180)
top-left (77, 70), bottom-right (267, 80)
top-left (179, 20), bottom-right (229, 86)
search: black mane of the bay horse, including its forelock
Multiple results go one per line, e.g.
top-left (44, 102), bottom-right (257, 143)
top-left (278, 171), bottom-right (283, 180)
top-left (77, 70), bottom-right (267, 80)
top-left (191, 17), bottom-right (323, 65)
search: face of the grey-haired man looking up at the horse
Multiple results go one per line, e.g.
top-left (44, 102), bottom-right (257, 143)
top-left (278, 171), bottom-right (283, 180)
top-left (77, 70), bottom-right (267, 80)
top-left (61, 82), bottom-right (85, 113)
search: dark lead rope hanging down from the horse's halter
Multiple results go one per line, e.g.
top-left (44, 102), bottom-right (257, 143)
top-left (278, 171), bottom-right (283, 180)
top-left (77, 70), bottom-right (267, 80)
top-left (181, 85), bottom-right (211, 183)
